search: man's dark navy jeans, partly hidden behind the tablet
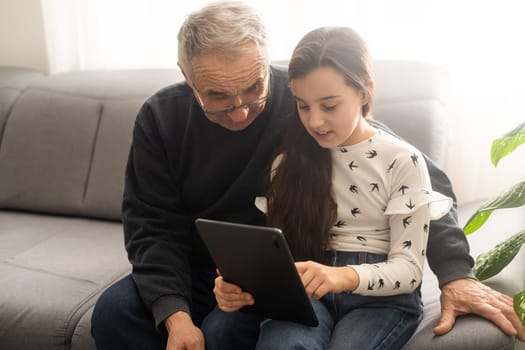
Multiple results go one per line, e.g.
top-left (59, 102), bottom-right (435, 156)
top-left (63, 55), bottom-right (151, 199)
top-left (91, 275), bottom-right (261, 350)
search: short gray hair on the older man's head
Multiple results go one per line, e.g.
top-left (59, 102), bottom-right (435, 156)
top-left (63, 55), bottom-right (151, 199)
top-left (178, 1), bottom-right (268, 75)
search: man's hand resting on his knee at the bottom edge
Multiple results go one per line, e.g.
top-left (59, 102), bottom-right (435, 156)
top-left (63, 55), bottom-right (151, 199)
top-left (164, 311), bottom-right (204, 350)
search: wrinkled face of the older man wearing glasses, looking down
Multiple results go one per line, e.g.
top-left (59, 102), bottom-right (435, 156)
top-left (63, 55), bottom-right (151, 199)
top-left (188, 43), bottom-right (269, 131)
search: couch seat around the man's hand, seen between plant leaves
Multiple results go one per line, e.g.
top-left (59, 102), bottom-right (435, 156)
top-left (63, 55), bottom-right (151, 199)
top-left (404, 201), bottom-right (525, 350)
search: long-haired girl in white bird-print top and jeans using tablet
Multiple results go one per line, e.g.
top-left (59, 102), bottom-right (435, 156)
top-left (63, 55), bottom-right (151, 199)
top-left (216, 27), bottom-right (452, 350)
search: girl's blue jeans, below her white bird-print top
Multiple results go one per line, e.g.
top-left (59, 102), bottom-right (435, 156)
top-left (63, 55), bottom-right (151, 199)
top-left (256, 252), bottom-right (423, 350)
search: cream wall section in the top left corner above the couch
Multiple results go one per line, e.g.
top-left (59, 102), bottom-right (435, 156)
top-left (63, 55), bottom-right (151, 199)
top-left (0, 0), bottom-right (48, 73)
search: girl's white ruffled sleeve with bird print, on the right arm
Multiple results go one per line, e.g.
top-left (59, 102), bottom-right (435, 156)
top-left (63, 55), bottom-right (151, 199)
top-left (352, 148), bottom-right (452, 296)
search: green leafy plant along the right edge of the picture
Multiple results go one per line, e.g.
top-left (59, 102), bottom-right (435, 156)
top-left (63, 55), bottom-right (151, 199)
top-left (464, 122), bottom-right (525, 327)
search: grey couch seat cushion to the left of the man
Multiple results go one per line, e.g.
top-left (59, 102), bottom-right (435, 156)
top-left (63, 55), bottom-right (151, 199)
top-left (0, 211), bottom-right (130, 349)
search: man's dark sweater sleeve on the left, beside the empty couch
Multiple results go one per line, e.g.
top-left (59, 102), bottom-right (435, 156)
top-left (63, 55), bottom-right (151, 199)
top-left (122, 104), bottom-right (191, 326)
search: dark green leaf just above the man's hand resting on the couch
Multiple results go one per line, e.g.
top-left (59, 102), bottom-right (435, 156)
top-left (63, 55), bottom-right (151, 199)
top-left (472, 230), bottom-right (525, 281)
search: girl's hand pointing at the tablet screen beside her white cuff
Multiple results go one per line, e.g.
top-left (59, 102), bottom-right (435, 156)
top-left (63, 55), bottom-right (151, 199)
top-left (295, 261), bottom-right (359, 299)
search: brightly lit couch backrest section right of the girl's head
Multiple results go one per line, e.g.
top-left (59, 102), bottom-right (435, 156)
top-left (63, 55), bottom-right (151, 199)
top-left (373, 60), bottom-right (450, 168)
